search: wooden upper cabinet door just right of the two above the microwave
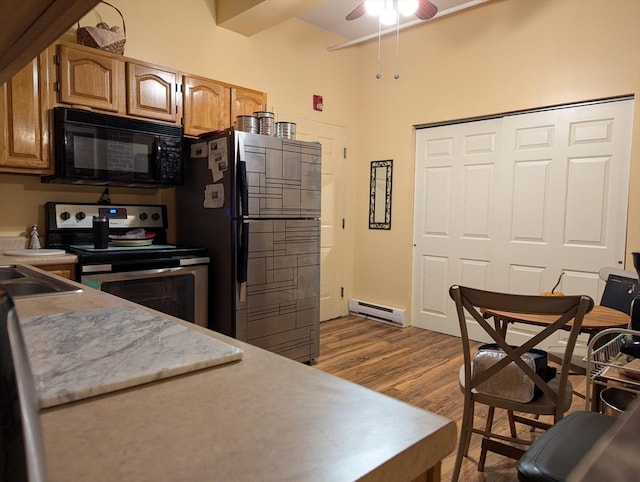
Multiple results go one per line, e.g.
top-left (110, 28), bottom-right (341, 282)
top-left (183, 75), bottom-right (230, 136)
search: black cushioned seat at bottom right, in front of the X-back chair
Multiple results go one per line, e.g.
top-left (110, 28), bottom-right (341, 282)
top-left (517, 412), bottom-right (618, 482)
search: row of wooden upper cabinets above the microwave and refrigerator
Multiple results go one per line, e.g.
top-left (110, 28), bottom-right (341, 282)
top-left (48, 42), bottom-right (267, 136)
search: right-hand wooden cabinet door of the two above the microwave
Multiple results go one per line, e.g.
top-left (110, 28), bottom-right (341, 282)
top-left (127, 62), bottom-right (178, 122)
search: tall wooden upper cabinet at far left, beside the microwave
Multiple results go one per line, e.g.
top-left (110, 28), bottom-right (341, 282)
top-left (0, 53), bottom-right (50, 174)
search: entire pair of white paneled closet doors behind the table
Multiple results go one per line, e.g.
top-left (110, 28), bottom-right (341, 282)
top-left (413, 100), bottom-right (633, 343)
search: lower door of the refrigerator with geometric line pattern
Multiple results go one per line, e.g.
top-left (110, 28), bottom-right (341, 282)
top-left (236, 219), bottom-right (320, 361)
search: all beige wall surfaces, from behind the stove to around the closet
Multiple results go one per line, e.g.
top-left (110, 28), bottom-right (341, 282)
top-left (0, 0), bottom-right (640, 326)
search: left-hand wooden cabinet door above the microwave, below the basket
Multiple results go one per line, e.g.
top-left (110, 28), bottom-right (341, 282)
top-left (58, 45), bottom-right (126, 113)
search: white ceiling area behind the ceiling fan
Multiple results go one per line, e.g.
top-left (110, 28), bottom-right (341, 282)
top-left (298, 0), bottom-right (489, 49)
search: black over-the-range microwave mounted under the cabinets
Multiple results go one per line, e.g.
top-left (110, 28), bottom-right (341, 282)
top-left (42, 107), bottom-right (184, 188)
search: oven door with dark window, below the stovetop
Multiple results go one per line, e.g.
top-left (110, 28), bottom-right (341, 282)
top-left (80, 265), bottom-right (209, 327)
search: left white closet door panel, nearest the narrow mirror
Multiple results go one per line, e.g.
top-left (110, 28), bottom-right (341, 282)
top-left (412, 119), bottom-right (502, 334)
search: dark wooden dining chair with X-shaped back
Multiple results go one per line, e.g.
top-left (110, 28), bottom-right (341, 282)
top-left (449, 285), bottom-right (593, 482)
